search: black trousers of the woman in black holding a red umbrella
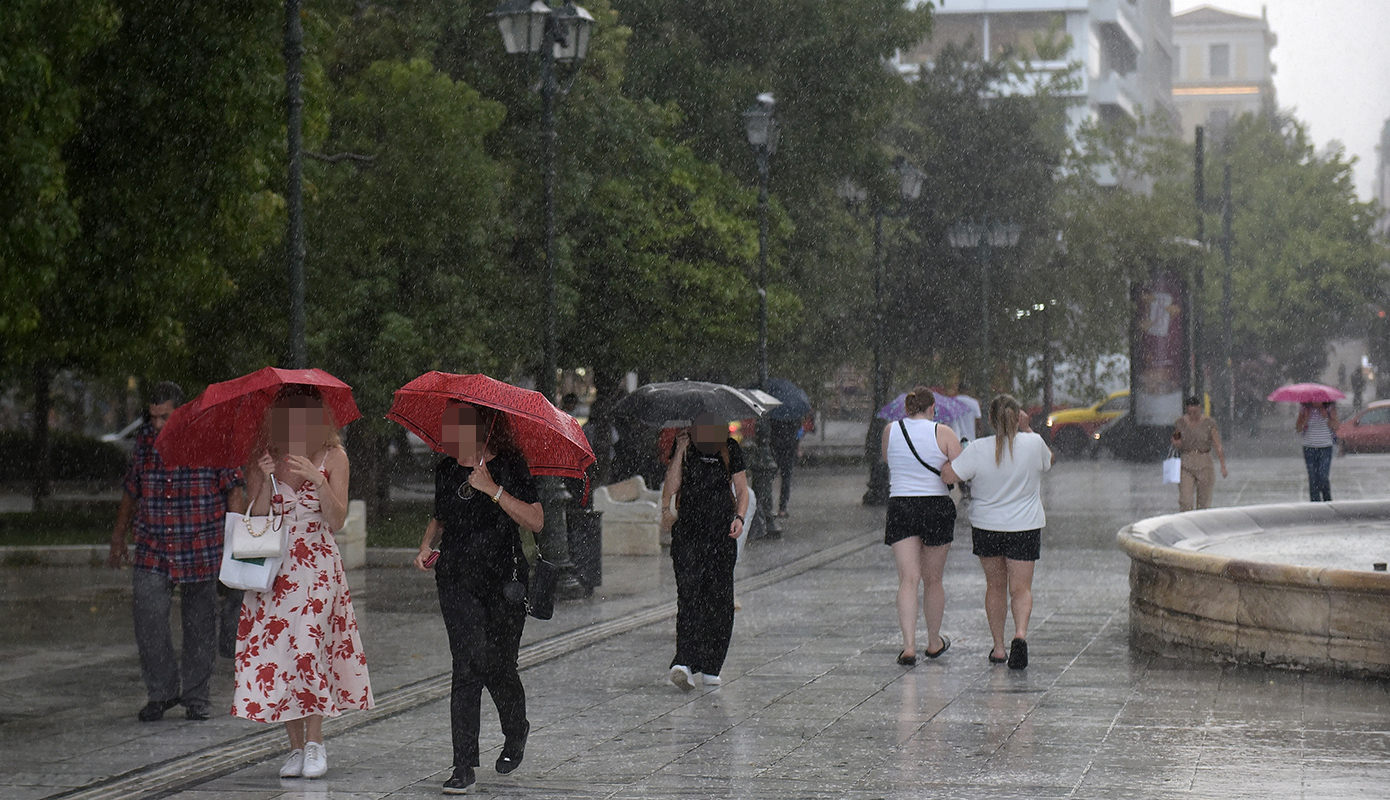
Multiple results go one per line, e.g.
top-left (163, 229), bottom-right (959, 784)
top-left (435, 575), bottom-right (527, 768)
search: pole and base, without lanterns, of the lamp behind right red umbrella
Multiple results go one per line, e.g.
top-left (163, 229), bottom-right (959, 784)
top-left (535, 14), bottom-right (578, 600)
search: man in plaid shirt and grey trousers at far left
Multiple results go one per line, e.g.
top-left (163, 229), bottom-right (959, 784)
top-left (107, 382), bottom-right (246, 722)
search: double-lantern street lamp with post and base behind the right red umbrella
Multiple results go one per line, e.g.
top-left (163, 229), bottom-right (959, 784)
top-left (491, 0), bottom-right (594, 600)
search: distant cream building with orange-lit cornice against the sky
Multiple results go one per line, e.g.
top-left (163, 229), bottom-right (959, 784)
top-left (1173, 6), bottom-right (1279, 142)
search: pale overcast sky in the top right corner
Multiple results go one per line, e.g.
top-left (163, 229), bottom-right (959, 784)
top-left (1173, 0), bottom-right (1390, 200)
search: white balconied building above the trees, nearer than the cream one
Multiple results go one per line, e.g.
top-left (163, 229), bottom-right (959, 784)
top-left (898, 0), bottom-right (1177, 137)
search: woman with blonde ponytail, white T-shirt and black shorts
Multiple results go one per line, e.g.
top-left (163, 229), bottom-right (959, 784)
top-left (942, 394), bottom-right (1055, 669)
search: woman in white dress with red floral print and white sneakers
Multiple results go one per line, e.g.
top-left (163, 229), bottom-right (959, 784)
top-left (232, 383), bottom-right (374, 778)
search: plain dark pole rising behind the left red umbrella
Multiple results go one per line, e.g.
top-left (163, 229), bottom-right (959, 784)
top-left (285, 0), bottom-right (309, 369)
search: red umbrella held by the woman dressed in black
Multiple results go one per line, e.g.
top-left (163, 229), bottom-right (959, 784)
top-left (386, 372), bottom-right (594, 478)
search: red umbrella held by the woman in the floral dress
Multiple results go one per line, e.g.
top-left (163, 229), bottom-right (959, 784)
top-left (154, 367), bottom-right (361, 467)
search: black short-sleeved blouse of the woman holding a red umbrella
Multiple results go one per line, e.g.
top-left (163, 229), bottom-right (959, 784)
top-left (434, 456), bottom-right (539, 585)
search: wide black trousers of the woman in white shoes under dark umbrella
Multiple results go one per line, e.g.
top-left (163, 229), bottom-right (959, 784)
top-left (671, 519), bottom-right (738, 675)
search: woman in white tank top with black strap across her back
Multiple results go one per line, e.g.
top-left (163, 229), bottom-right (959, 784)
top-left (881, 386), bottom-right (960, 667)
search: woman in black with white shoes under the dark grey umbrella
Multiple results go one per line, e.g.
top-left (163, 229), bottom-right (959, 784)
top-left (662, 415), bottom-right (748, 692)
